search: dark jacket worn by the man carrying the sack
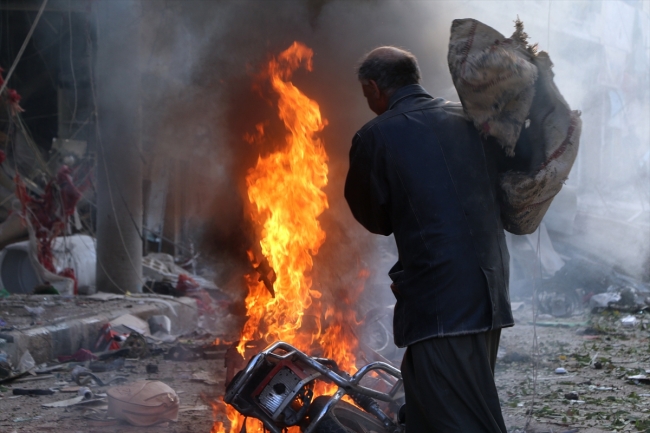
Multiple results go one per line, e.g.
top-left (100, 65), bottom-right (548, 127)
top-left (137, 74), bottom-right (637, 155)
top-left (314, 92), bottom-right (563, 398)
top-left (345, 84), bottom-right (513, 347)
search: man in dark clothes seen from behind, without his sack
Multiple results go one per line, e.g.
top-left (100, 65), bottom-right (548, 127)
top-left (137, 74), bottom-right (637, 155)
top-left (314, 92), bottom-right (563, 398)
top-left (345, 47), bottom-right (513, 433)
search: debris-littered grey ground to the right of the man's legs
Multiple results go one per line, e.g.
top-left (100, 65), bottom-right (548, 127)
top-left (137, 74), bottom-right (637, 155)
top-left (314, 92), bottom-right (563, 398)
top-left (495, 307), bottom-right (650, 433)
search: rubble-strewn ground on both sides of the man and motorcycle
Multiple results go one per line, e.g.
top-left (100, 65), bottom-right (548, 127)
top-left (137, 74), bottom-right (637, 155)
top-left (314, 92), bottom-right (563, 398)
top-left (0, 306), bottom-right (650, 433)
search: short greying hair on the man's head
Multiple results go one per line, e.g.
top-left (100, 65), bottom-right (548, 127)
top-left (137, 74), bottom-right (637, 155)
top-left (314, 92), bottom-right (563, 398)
top-left (357, 46), bottom-right (420, 96)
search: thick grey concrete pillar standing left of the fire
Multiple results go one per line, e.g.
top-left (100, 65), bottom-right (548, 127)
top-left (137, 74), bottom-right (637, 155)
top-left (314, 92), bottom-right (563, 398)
top-left (93, 0), bottom-right (142, 293)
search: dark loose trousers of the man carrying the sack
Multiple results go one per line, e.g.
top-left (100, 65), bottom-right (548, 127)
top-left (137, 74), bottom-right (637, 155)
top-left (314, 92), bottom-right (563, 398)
top-left (402, 329), bottom-right (506, 433)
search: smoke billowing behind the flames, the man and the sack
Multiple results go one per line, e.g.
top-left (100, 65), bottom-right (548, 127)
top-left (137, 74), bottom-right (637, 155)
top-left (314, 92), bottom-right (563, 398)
top-left (104, 0), bottom-right (650, 318)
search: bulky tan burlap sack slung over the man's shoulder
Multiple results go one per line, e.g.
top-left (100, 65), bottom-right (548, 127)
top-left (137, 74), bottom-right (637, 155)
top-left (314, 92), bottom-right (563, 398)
top-left (448, 19), bottom-right (582, 234)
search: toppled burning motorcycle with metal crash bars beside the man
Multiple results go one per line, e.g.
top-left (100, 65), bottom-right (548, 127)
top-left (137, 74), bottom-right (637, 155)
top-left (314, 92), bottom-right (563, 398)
top-left (224, 341), bottom-right (405, 433)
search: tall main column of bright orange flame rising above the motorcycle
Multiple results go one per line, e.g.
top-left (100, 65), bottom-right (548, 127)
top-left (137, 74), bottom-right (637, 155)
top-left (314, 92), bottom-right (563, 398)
top-left (238, 42), bottom-right (328, 354)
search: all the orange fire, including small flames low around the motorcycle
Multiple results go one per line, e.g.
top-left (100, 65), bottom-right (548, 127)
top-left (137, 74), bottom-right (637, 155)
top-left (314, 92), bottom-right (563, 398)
top-left (212, 42), bottom-right (357, 433)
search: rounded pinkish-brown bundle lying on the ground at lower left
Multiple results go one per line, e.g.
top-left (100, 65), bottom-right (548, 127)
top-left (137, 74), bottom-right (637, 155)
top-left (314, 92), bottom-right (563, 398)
top-left (106, 381), bottom-right (180, 426)
